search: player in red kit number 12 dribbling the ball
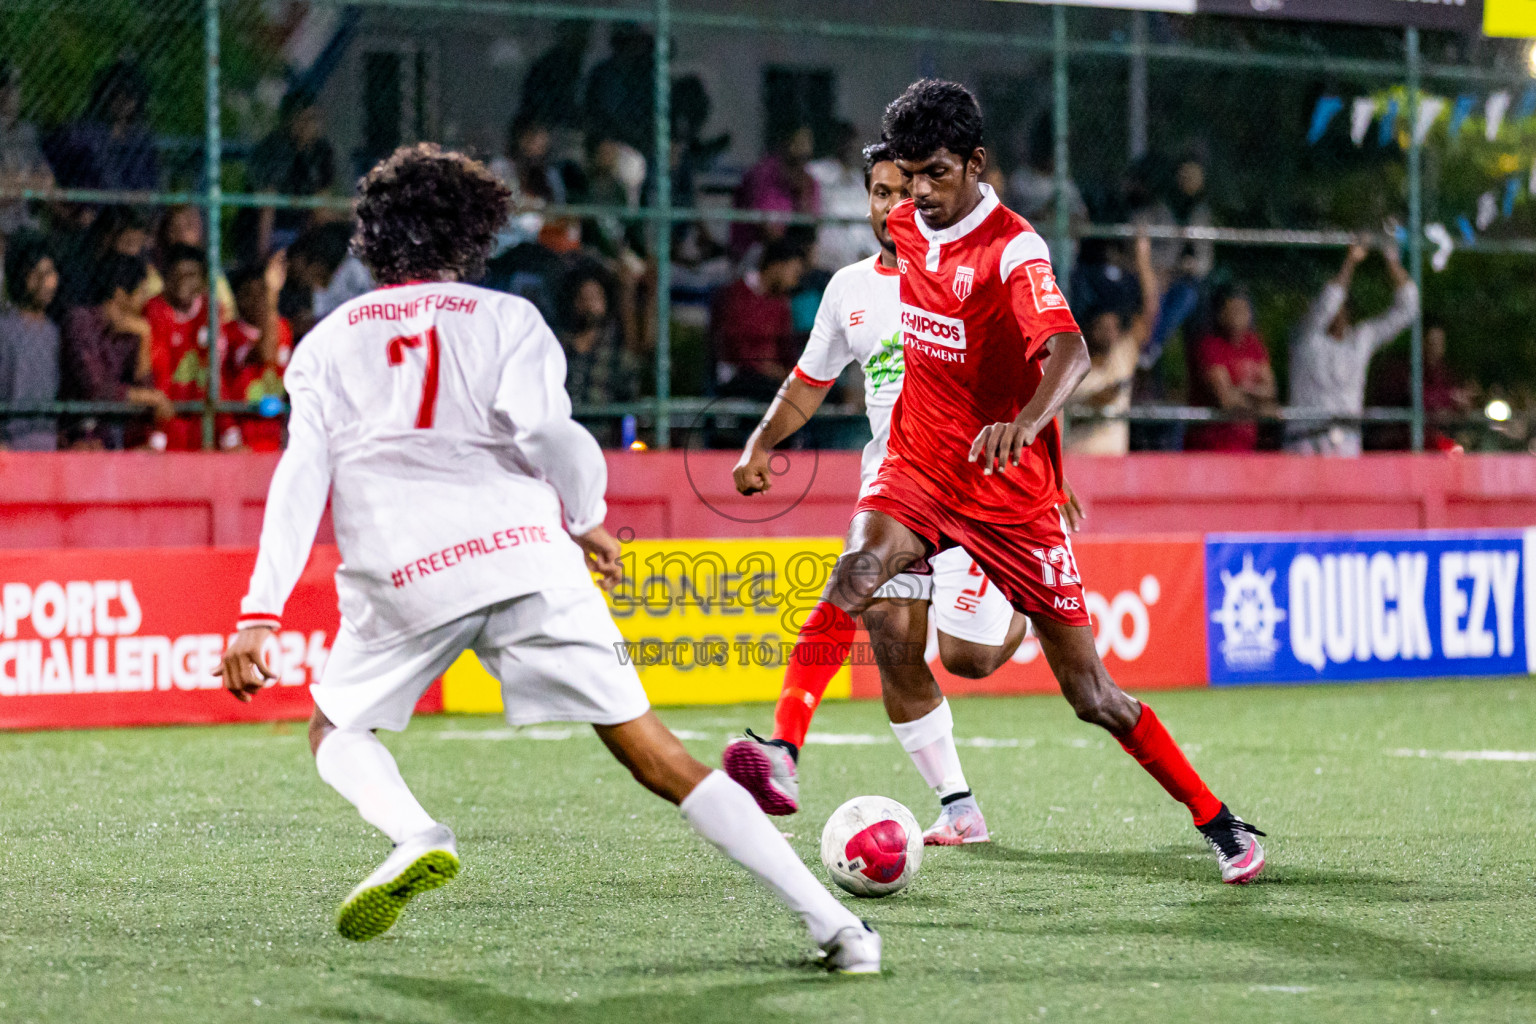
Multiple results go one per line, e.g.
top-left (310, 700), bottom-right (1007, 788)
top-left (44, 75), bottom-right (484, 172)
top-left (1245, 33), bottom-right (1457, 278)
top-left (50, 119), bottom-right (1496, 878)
top-left (724, 78), bottom-right (1264, 883)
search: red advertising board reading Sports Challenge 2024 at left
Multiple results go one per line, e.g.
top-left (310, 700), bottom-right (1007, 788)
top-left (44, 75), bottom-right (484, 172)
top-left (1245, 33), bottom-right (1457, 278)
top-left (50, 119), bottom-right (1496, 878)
top-left (0, 547), bottom-right (441, 729)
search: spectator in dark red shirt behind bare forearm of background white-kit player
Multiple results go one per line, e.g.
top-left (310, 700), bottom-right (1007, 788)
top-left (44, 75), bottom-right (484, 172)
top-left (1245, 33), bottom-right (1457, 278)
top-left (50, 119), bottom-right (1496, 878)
top-left (710, 238), bottom-right (806, 402)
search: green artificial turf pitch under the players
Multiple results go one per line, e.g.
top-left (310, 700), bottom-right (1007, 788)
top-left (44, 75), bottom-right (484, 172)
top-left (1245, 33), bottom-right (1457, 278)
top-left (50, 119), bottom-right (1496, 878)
top-left (0, 679), bottom-right (1536, 1024)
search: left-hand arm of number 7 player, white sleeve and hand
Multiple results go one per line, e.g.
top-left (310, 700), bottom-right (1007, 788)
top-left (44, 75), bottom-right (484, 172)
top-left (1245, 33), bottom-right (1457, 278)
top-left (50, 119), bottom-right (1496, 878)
top-left (215, 376), bottom-right (330, 703)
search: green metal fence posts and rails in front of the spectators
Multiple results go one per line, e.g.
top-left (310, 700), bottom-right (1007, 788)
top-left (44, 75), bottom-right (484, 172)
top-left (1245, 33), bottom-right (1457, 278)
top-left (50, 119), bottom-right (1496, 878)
top-left (0, 0), bottom-right (1536, 450)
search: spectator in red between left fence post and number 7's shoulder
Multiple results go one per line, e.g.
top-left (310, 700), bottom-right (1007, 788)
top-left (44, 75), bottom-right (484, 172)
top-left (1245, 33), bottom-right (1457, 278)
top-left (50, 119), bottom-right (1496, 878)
top-left (220, 253), bottom-right (293, 451)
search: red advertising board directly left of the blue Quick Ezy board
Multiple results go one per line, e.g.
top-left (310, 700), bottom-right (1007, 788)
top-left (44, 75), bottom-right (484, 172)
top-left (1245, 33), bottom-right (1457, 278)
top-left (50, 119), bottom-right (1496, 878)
top-left (852, 536), bottom-right (1209, 699)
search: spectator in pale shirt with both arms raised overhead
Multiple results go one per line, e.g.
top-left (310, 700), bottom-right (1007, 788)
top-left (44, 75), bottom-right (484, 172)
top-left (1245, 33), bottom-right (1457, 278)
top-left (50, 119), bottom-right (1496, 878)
top-left (1286, 239), bottom-right (1419, 456)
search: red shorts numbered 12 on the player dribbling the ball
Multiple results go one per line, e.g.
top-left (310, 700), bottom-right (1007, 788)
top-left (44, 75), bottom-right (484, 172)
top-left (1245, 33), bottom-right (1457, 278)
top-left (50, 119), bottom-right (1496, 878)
top-left (857, 462), bottom-right (1091, 626)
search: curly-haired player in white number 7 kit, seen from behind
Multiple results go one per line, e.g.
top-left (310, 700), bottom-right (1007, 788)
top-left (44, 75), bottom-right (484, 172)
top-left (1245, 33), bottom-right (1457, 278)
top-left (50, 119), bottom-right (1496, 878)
top-left (220, 144), bottom-right (880, 973)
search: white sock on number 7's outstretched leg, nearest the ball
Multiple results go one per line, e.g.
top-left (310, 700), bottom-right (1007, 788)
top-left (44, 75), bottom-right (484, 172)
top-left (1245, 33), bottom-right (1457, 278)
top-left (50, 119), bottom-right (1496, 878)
top-left (680, 772), bottom-right (859, 944)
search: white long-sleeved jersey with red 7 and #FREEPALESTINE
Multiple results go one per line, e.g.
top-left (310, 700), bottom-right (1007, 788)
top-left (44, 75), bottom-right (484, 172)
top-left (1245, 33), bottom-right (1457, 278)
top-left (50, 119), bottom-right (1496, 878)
top-left (240, 282), bottom-right (607, 646)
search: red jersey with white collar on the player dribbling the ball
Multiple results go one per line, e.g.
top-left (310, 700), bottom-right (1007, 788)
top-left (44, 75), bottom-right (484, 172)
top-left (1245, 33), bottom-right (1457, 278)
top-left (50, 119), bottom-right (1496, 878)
top-left (886, 184), bottom-right (1078, 522)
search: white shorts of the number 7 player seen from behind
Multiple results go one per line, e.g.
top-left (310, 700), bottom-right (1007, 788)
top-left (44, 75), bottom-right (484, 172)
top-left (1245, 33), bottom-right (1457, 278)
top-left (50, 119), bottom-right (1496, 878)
top-left (310, 586), bottom-right (651, 732)
